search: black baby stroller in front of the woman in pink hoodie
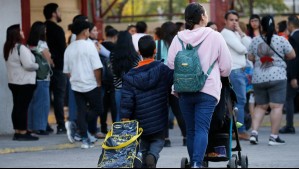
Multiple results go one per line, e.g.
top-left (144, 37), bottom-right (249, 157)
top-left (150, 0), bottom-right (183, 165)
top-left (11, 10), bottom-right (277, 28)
top-left (181, 78), bottom-right (248, 168)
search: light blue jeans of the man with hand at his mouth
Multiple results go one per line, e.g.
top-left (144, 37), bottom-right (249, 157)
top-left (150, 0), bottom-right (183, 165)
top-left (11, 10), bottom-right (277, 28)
top-left (229, 69), bottom-right (246, 133)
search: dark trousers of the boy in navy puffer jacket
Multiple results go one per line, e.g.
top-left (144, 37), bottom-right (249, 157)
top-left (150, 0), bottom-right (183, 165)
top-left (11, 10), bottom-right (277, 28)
top-left (140, 131), bottom-right (165, 168)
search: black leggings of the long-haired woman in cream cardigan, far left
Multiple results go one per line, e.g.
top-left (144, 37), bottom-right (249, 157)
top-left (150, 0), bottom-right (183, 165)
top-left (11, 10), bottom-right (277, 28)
top-left (8, 84), bottom-right (36, 130)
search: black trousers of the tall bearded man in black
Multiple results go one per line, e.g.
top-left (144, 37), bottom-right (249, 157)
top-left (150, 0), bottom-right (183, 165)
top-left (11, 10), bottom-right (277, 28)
top-left (51, 69), bottom-right (67, 128)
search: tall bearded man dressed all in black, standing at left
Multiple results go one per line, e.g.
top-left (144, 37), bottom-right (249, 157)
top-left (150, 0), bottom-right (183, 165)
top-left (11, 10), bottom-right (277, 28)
top-left (43, 3), bottom-right (67, 134)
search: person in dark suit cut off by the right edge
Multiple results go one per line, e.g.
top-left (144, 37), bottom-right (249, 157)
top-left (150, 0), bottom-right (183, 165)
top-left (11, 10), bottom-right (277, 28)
top-left (279, 16), bottom-right (299, 134)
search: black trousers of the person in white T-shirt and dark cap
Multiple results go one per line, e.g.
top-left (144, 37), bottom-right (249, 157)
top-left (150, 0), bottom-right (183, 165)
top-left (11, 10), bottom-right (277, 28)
top-left (75, 87), bottom-right (102, 138)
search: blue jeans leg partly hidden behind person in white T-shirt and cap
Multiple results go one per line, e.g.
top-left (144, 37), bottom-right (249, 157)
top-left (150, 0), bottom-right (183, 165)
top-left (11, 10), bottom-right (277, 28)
top-left (68, 80), bottom-right (77, 122)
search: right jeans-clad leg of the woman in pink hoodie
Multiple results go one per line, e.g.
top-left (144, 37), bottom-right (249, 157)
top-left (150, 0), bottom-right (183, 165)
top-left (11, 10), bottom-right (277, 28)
top-left (192, 93), bottom-right (217, 167)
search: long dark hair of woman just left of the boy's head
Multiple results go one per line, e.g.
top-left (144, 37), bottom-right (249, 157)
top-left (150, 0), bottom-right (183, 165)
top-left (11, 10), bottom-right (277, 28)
top-left (111, 31), bottom-right (139, 78)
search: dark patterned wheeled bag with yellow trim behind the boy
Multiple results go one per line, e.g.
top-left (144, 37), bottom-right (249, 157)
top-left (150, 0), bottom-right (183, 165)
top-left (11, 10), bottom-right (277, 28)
top-left (98, 121), bottom-right (143, 168)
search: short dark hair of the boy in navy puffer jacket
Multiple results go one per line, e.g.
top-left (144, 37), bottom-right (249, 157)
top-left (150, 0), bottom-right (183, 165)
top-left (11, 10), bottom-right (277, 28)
top-left (138, 35), bottom-right (156, 58)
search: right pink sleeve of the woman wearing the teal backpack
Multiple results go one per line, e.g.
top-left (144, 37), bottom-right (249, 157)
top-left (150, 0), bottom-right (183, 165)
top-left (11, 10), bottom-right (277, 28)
top-left (217, 34), bottom-right (232, 77)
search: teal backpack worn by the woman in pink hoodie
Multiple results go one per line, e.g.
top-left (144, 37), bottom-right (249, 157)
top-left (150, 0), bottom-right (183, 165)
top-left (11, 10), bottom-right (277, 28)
top-left (174, 38), bottom-right (216, 93)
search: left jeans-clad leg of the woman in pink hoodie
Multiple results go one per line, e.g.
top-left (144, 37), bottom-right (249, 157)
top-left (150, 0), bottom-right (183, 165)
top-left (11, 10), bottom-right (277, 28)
top-left (179, 94), bottom-right (195, 163)
